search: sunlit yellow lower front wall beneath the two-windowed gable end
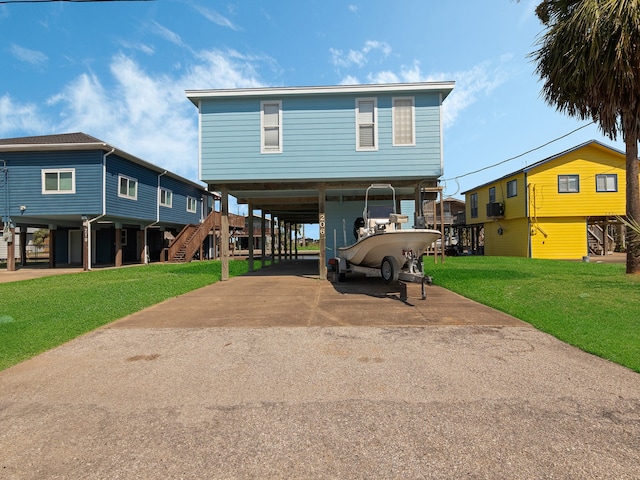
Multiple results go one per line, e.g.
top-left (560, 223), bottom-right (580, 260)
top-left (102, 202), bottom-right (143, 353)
top-left (531, 217), bottom-right (588, 260)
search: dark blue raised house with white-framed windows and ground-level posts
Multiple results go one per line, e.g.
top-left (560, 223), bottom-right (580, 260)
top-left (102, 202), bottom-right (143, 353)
top-left (0, 133), bottom-right (212, 269)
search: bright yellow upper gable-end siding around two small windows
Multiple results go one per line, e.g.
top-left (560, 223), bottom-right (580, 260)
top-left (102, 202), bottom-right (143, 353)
top-left (527, 145), bottom-right (626, 219)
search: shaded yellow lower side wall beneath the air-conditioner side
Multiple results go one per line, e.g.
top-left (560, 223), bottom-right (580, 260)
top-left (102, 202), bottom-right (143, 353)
top-left (484, 218), bottom-right (529, 257)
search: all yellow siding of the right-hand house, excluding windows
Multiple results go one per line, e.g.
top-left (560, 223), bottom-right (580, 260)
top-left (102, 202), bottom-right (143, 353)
top-left (465, 143), bottom-right (626, 259)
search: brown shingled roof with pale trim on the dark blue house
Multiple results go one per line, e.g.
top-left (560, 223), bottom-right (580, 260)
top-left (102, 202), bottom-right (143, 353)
top-left (0, 132), bottom-right (206, 190)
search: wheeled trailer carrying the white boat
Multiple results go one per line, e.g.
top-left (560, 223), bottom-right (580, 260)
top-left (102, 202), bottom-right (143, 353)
top-left (329, 251), bottom-right (433, 300)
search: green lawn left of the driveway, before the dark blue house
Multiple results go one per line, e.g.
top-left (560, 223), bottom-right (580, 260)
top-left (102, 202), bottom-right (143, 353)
top-left (0, 260), bottom-right (261, 370)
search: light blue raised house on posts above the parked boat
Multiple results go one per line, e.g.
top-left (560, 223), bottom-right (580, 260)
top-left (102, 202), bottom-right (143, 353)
top-left (186, 82), bottom-right (454, 276)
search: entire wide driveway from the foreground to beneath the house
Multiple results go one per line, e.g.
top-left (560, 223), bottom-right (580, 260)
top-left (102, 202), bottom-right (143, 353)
top-left (0, 261), bottom-right (640, 479)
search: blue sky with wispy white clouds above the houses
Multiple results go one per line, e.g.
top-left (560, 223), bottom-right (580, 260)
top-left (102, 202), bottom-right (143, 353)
top-left (0, 0), bottom-right (624, 234)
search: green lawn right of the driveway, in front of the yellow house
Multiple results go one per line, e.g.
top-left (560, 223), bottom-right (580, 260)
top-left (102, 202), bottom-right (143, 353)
top-left (425, 256), bottom-right (640, 372)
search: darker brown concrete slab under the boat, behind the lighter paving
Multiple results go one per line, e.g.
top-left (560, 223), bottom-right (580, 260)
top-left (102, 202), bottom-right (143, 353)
top-left (110, 260), bottom-right (528, 328)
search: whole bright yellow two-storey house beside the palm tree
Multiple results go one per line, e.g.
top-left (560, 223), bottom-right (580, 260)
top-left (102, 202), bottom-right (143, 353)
top-left (464, 140), bottom-right (626, 259)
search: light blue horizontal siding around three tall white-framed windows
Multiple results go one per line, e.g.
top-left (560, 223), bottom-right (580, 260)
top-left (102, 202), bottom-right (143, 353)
top-left (200, 92), bottom-right (441, 183)
